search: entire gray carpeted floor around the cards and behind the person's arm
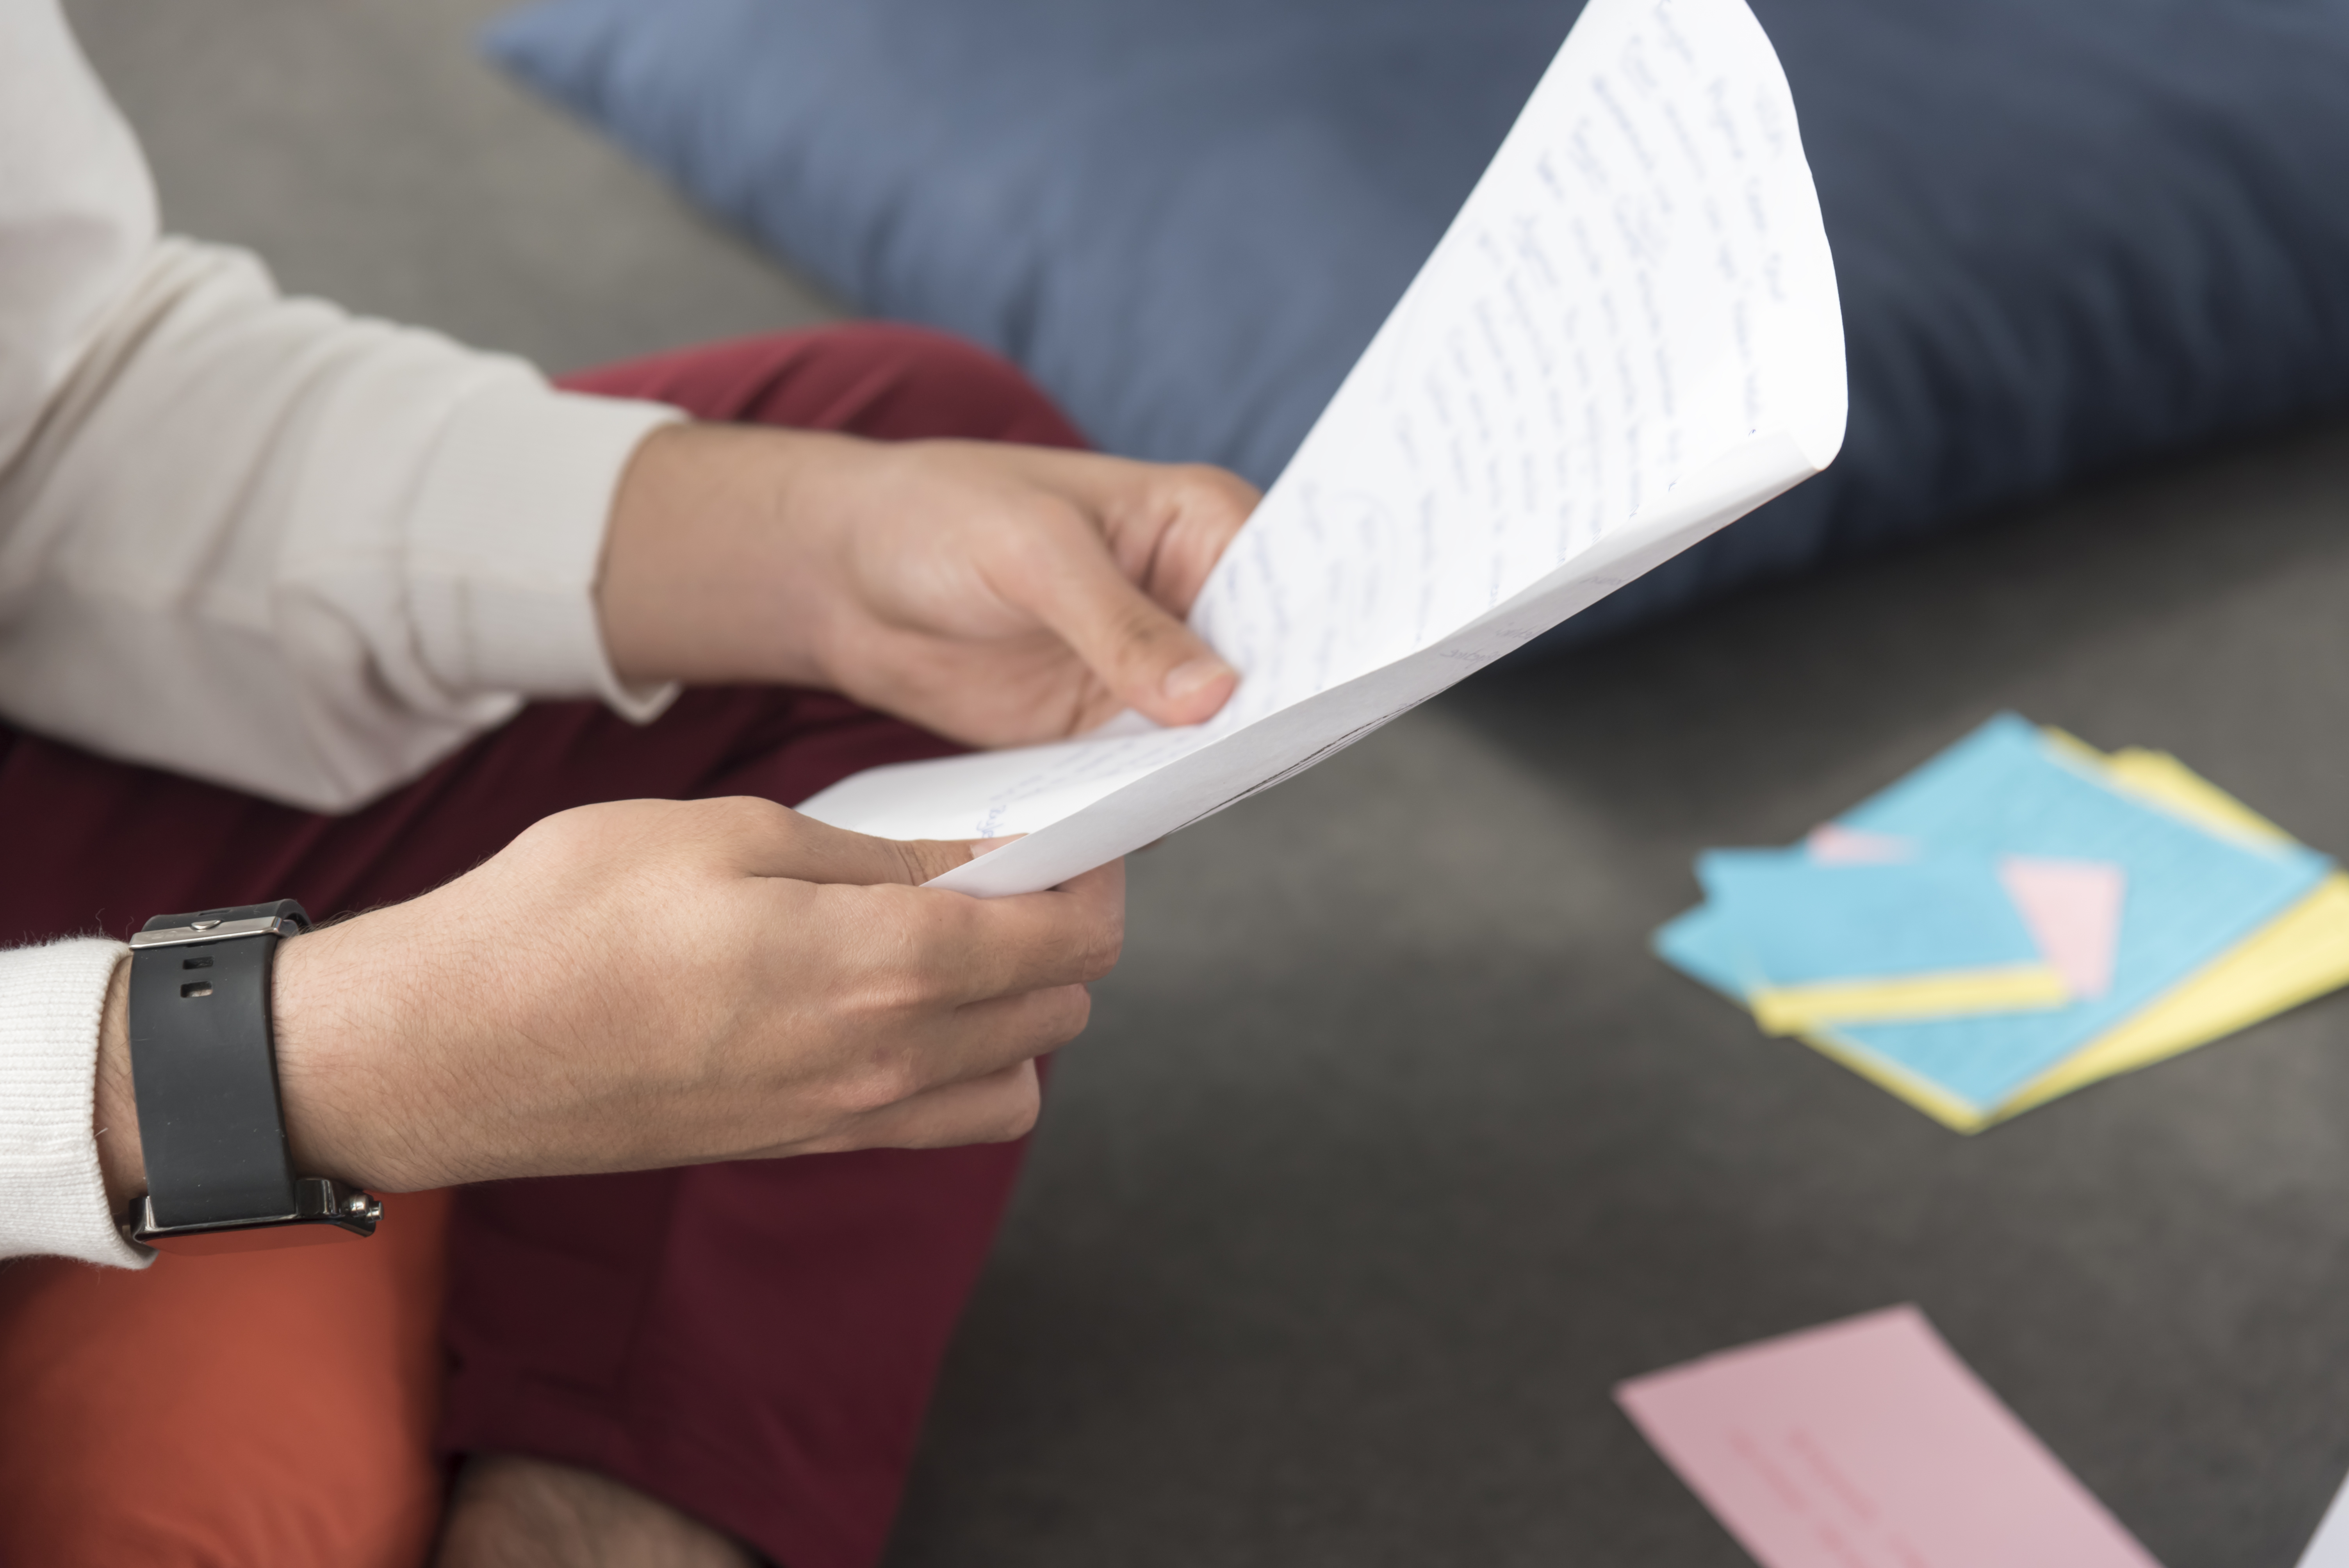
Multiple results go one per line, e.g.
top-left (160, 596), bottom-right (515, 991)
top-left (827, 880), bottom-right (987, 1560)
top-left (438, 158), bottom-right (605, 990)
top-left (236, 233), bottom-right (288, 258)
top-left (73, 0), bottom-right (2349, 1568)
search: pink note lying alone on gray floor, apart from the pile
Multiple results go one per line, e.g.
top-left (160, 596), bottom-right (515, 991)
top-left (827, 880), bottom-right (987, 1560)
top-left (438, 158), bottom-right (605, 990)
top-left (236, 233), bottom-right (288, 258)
top-left (1616, 1308), bottom-right (2159, 1568)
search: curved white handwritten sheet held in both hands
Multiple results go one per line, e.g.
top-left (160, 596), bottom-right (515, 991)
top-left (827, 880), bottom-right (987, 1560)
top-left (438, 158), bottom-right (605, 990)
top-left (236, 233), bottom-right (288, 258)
top-left (801, 0), bottom-right (1844, 897)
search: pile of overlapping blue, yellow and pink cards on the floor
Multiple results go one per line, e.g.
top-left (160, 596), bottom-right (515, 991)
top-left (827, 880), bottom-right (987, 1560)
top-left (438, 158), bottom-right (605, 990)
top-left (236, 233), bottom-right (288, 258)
top-left (1656, 714), bottom-right (2349, 1131)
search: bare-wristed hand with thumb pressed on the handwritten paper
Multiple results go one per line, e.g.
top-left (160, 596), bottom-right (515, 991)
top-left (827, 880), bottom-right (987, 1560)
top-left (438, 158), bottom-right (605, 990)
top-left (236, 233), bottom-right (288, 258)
top-left (599, 425), bottom-right (1257, 747)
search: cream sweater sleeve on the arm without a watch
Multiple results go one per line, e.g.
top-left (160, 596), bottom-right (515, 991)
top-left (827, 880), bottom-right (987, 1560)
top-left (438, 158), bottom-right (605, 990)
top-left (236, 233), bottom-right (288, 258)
top-left (0, 0), bottom-right (679, 810)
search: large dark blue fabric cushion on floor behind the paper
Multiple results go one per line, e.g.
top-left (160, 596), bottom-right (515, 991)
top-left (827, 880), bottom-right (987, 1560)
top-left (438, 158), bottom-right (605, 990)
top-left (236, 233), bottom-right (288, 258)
top-left (486, 0), bottom-right (2349, 636)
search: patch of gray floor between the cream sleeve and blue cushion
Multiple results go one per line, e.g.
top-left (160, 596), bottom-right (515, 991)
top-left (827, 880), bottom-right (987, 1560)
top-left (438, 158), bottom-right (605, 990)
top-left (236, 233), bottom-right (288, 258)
top-left (66, 0), bottom-right (839, 371)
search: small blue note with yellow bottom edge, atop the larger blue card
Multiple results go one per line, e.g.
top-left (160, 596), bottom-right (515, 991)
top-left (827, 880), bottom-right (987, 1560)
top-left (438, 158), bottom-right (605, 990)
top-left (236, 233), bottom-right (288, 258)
top-left (1696, 850), bottom-right (2044, 993)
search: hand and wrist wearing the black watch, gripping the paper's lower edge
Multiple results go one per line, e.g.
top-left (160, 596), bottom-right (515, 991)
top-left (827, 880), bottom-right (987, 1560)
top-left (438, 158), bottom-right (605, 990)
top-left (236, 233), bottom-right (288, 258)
top-left (96, 800), bottom-right (1125, 1206)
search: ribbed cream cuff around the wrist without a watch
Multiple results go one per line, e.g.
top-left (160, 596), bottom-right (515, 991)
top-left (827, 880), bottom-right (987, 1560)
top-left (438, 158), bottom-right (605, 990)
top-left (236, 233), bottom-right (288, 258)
top-left (406, 378), bottom-right (684, 723)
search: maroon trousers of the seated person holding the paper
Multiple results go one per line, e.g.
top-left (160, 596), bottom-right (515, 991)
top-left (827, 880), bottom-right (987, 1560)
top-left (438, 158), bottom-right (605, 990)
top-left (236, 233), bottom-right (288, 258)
top-left (0, 324), bottom-right (1080, 1568)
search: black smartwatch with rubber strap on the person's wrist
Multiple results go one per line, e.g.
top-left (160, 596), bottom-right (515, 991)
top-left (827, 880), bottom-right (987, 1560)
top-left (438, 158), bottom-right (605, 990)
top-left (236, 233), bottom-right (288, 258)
top-left (120, 899), bottom-right (383, 1251)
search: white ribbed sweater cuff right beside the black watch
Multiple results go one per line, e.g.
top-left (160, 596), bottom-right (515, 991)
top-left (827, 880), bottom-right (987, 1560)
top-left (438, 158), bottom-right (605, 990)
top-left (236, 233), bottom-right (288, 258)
top-left (0, 937), bottom-right (148, 1267)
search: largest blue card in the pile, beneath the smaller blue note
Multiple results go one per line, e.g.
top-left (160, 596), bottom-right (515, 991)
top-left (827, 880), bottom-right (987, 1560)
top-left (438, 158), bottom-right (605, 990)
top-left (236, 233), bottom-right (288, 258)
top-left (1804, 714), bottom-right (2330, 1113)
